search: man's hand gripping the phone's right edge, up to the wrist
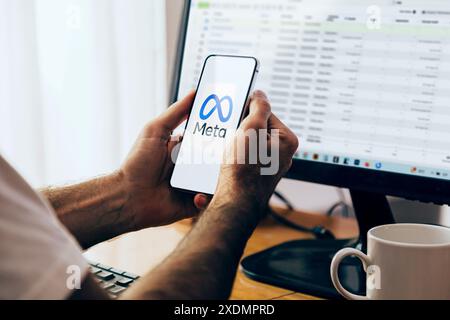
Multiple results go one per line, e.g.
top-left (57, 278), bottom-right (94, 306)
top-left (204, 91), bottom-right (298, 219)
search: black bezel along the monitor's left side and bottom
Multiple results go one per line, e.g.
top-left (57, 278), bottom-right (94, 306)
top-left (170, 0), bottom-right (450, 204)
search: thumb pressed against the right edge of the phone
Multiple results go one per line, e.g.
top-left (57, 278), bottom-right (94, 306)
top-left (241, 91), bottom-right (271, 129)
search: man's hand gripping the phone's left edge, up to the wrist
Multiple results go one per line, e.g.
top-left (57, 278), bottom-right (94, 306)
top-left (120, 92), bottom-right (204, 229)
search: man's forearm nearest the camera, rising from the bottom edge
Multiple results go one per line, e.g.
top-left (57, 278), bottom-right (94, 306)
top-left (125, 198), bottom-right (263, 299)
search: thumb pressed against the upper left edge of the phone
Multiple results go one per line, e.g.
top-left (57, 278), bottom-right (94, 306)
top-left (155, 91), bottom-right (195, 131)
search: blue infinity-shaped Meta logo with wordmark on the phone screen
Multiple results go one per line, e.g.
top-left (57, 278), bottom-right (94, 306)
top-left (194, 94), bottom-right (233, 138)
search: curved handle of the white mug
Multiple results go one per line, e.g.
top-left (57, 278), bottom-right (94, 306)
top-left (330, 248), bottom-right (371, 300)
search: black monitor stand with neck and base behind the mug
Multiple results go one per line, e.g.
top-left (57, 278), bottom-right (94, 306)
top-left (241, 190), bottom-right (395, 298)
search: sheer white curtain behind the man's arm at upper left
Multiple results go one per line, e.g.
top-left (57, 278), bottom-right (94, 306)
top-left (0, 0), bottom-right (167, 186)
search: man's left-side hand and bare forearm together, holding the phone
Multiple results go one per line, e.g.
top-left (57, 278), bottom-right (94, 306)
top-left (40, 92), bottom-right (205, 248)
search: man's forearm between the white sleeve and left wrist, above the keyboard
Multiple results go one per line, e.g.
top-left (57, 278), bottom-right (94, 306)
top-left (39, 173), bottom-right (133, 248)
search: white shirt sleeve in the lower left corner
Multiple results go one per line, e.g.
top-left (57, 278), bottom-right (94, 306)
top-left (0, 156), bottom-right (88, 299)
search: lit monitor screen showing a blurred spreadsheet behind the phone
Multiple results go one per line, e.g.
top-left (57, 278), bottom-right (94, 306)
top-left (178, 0), bottom-right (450, 185)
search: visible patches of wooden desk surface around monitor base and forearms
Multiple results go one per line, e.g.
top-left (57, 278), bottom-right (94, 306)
top-left (85, 210), bottom-right (358, 300)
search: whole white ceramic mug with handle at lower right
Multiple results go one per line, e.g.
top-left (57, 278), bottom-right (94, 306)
top-left (330, 224), bottom-right (450, 300)
